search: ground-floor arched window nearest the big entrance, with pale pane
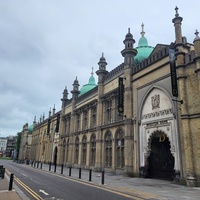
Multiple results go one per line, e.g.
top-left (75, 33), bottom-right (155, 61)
top-left (115, 130), bottom-right (124, 168)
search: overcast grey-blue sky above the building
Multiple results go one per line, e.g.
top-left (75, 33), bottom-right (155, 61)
top-left (0, 0), bottom-right (200, 137)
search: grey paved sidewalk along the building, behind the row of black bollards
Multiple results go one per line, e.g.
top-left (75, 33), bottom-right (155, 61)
top-left (29, 164), bottom-right (200, 200)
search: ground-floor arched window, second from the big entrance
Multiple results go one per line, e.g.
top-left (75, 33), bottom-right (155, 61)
top-left (105, 132), bottom-right (112, 167)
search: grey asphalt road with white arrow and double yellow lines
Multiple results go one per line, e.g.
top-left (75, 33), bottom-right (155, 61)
top-left (3, 161), bottom-right (134, 200)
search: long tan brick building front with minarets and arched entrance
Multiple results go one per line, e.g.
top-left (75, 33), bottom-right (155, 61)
top-left (26, 8), bottom-right (200, 186)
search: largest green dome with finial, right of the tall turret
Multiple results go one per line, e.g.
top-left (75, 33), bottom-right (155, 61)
top-left (134, 24), bottom-right (154, 64)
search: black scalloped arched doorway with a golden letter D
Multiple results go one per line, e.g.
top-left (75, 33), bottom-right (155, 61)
top-left (147, 131), bottom-right (174, 180)
